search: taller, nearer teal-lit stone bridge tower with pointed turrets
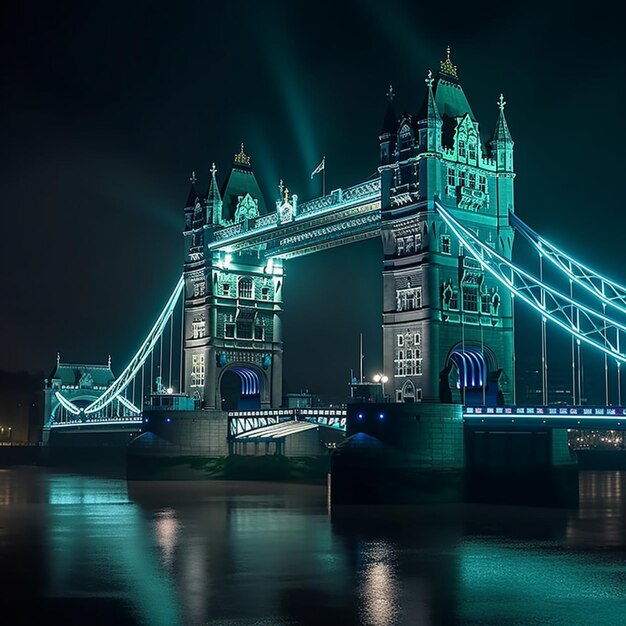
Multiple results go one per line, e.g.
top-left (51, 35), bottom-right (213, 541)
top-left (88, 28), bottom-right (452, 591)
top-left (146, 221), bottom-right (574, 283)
top-left (380, 48), bottom-right (515, 404)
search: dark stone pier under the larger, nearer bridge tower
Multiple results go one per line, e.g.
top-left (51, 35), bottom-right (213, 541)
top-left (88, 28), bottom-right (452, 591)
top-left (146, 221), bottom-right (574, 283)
top-left (331, 402), bottom-right (578, 507)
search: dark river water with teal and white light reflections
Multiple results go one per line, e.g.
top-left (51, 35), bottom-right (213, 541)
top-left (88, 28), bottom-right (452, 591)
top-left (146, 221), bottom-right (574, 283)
top-left (0, 468), bottom-right (626, 626)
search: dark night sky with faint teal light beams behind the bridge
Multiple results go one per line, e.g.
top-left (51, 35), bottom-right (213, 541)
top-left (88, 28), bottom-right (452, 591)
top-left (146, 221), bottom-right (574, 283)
top-left (0, 0), bottom-right (626, 395)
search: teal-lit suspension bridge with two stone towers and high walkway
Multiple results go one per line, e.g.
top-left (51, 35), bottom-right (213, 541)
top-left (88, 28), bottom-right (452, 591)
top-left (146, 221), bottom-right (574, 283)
top-left (45, 54), bottom-right (626, 504)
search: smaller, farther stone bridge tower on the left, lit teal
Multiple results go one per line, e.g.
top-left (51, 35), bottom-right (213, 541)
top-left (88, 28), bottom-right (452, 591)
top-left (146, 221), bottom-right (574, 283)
top-left (183, 144), bottom-right (283, 410)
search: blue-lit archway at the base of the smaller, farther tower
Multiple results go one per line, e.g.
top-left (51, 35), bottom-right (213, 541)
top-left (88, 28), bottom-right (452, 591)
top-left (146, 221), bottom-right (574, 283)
top-left (215, 363), bottom-right (270, 411)
